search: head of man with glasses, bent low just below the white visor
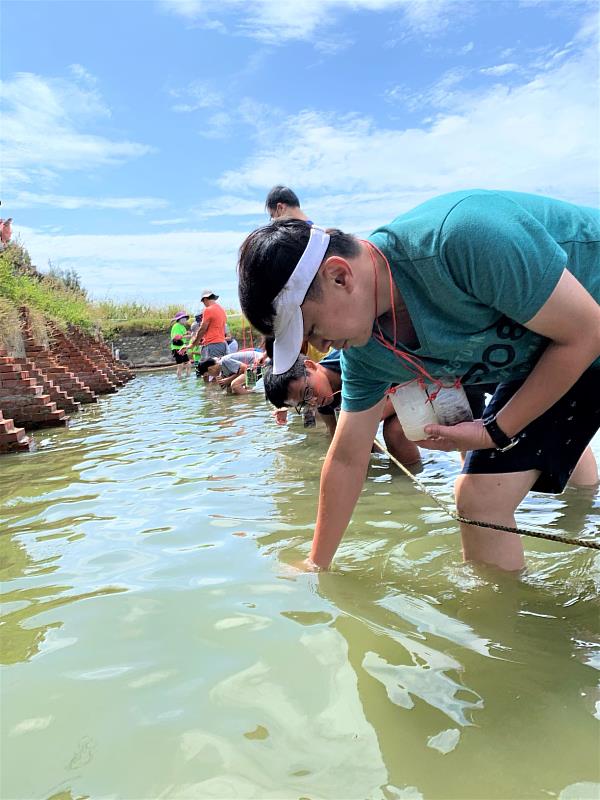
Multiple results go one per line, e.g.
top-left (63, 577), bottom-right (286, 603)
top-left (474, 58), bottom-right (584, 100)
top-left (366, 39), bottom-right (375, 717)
top-left (263, 355), bottom-right (334, 410)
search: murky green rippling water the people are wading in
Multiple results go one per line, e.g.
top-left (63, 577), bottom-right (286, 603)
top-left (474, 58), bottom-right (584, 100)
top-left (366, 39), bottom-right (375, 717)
top-left (0, 373), bottom-right (600, 800)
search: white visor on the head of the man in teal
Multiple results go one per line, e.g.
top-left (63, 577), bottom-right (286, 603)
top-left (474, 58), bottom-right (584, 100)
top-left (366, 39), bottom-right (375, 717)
top-left (273, 225), bottom-right (329, 375)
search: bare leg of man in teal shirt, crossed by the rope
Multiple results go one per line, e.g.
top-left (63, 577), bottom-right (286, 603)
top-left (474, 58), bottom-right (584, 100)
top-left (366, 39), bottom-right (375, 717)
top-left (455, 469), bottom-right (540, 570)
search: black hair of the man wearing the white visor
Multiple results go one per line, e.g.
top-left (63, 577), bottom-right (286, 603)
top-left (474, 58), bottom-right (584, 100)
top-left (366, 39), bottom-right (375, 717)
top-left (238, 217), bottom-right (360, 336)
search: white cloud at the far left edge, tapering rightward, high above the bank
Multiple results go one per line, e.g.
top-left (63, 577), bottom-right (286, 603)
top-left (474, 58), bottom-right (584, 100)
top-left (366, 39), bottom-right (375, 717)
top-left (0, 72), bottom-right (152, 185)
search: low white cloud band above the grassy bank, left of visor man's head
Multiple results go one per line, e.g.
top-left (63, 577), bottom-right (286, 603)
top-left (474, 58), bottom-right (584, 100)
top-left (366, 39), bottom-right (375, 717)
top-left (14, 226), bottom-right (245, 306)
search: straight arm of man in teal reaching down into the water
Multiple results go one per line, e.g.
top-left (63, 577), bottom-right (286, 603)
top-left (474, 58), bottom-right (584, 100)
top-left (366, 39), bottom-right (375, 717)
top-left (309, 400), bottom-right (383, 569)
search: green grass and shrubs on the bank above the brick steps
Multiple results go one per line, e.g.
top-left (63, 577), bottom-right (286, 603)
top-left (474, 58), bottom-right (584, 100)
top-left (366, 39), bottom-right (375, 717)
top-left (0, 242), bottom-right (261, 343)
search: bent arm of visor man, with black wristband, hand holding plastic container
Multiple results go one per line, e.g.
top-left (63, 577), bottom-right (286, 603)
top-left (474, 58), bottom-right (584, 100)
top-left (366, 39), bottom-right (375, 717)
top-left (418, 270), bottom-right (600, 450)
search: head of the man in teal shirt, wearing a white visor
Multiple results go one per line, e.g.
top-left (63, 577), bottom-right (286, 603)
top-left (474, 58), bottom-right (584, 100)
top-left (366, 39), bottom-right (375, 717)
top-left (238, 218), bottom-right (374, 372)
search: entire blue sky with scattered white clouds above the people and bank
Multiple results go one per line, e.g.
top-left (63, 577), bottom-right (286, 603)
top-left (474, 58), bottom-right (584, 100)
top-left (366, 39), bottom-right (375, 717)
top-left (0, 0), bottom-right (600, 309)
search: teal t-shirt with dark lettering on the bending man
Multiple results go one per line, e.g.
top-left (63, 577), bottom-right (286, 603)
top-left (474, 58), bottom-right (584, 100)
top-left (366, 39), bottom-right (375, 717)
top-left (342, 190), bottom-right (600, 411)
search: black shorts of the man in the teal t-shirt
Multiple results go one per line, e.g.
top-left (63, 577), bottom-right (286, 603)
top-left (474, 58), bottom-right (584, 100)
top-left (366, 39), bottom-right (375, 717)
top-left (463, 367), bottom-right (600, 493)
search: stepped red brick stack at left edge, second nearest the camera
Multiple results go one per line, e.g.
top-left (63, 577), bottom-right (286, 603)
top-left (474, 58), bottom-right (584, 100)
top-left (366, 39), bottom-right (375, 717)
top-left (0, 351), bottom-right (69, 428)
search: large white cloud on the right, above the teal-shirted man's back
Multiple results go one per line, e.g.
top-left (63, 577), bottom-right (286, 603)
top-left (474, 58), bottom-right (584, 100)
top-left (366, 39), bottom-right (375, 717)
top-left (220, 13), bottom-right (600, 225)
